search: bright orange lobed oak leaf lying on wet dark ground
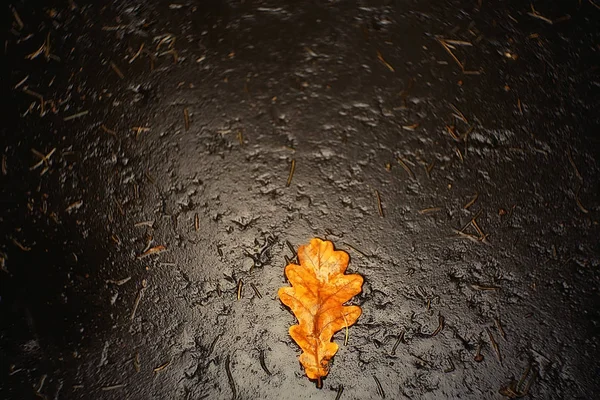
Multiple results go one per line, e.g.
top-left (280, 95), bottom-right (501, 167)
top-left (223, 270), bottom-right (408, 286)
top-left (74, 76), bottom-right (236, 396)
top-left (278, 239), bottom-right (363, 387)
